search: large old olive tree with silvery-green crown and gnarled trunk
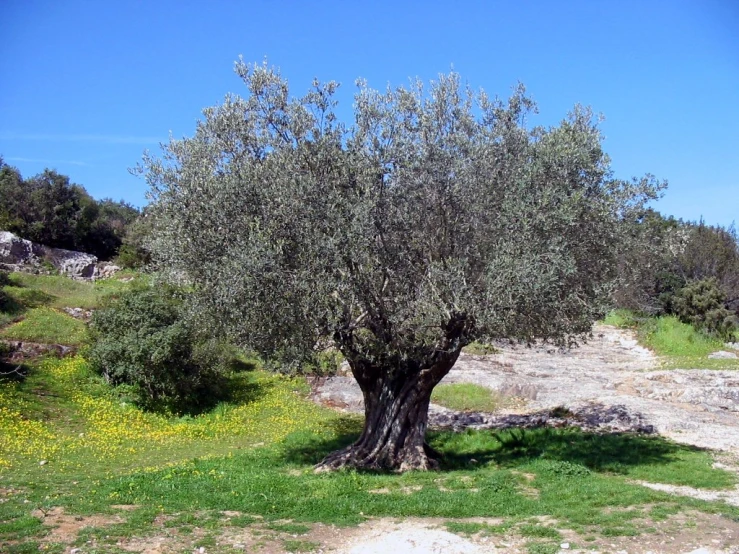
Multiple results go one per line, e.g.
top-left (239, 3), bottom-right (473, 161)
top-left (139, 61), bottom-right (660, 471)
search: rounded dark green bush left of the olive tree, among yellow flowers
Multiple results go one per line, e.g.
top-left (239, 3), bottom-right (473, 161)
top-left (87, 288), bottom-right (229, 413)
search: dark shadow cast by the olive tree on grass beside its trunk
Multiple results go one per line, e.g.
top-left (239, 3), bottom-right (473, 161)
top-left (284, 417), bottom-right (700, 473)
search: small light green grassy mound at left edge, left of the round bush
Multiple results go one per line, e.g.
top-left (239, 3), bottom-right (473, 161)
top-left (0, 307), bottom-right (87, 346)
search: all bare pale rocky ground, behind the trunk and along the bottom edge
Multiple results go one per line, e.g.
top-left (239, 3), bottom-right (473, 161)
top-left (313, 325), bottom-right (739, 554)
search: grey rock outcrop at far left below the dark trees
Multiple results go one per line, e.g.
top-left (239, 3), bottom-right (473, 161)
top-left (0, 231), bottom-right (120, 280)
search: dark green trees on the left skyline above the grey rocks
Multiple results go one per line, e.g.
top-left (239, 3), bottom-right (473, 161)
top-left (0, 157), bottom-right (149, 265)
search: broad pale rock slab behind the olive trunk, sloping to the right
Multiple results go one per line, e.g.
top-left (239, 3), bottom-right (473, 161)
top-left (314, 325), bottom-right (739, 454)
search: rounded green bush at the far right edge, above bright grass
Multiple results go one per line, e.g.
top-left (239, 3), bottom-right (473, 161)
top-left (672, 279), bottom-right (736, 339)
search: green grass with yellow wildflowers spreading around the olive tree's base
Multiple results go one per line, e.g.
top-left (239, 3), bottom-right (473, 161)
top-left (0, 276), bottom-right (739, 554)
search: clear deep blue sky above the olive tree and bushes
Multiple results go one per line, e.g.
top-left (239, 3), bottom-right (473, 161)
top-left (0, 0), bottom-right (739, 225)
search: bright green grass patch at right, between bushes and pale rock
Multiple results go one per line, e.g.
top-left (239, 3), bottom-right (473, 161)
top-left (605, 310), bottom-right (739, 369)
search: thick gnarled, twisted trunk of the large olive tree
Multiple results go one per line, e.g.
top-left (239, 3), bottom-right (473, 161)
top-left (316, 351), bottom-right (459, 472)
